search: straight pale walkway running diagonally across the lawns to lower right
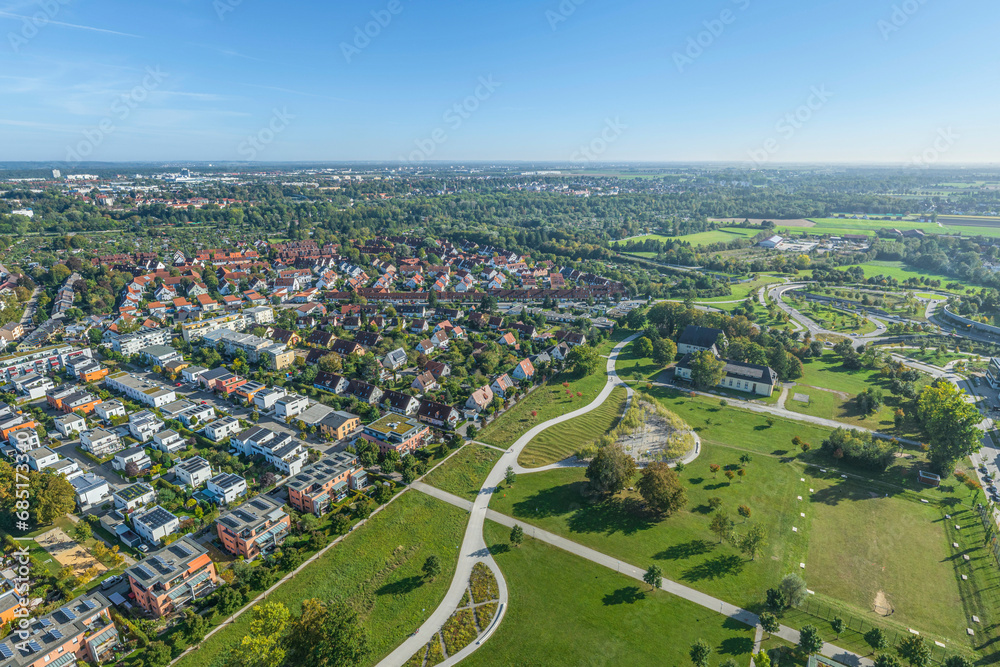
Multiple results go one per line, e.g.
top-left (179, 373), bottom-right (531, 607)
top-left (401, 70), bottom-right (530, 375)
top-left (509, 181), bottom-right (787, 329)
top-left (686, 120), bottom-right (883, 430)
top-left (414, 484), bottom-right (873, 666)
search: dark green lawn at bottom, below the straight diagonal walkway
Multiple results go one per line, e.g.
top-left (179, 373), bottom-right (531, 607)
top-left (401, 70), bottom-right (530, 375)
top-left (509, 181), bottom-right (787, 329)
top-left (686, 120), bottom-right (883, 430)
top-left (462, 521), bottom-right (753, 667)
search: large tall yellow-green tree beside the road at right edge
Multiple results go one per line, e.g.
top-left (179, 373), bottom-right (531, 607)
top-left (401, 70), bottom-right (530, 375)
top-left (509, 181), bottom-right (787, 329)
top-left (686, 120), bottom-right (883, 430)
top-left (917, 380), bottom-right (983, 475)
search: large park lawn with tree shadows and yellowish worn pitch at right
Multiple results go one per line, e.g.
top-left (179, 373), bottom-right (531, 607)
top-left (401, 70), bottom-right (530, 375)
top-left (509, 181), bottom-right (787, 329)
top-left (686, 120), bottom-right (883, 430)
top-left (492, 389), bottom-right (994, 650)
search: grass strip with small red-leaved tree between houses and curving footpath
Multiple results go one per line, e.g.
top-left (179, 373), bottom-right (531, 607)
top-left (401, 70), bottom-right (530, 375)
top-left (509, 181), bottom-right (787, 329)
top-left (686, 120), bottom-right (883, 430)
top-left (476, 364), bottom-right (608, 448)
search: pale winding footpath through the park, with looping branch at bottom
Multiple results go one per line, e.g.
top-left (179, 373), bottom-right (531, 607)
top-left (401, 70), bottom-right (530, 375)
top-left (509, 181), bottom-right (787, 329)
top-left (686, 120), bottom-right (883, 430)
top-left (378, 332), bottom-right (642, 667)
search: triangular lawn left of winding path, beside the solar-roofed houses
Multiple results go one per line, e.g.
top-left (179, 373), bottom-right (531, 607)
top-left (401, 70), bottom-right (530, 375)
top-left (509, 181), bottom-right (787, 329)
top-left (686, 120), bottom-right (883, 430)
top-left (178, 492), bottom-right (468, 667)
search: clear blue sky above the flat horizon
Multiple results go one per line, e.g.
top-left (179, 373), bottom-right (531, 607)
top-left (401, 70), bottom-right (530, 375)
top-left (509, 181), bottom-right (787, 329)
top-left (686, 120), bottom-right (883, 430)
top-left (0, 0), bottom-right (1000, 164)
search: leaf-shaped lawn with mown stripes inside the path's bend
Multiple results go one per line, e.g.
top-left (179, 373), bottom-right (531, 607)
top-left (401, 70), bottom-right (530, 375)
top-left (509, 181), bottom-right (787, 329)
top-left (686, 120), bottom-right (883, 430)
top-left (517, 386), bottom-right (631, 468)
